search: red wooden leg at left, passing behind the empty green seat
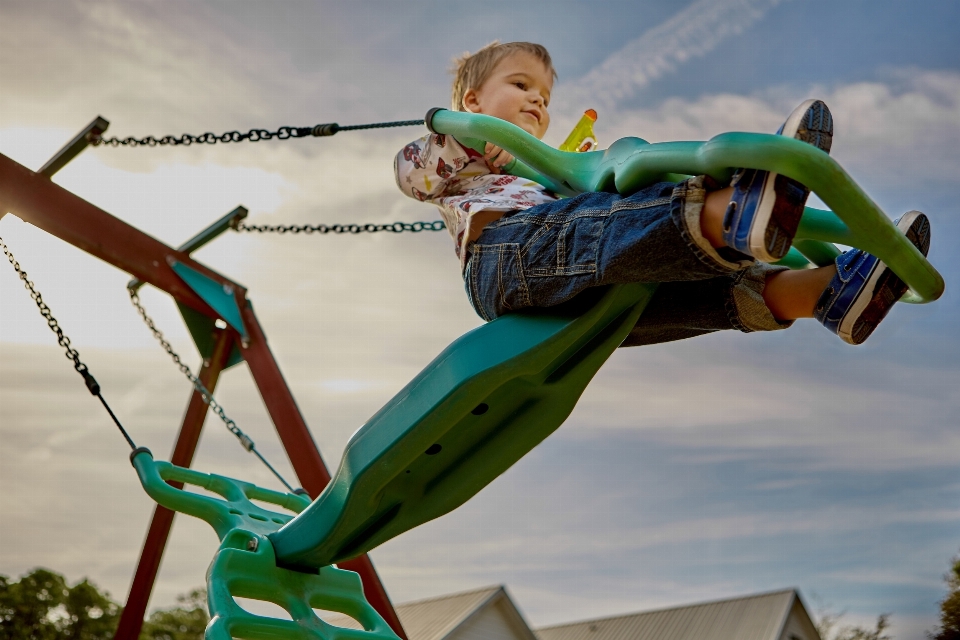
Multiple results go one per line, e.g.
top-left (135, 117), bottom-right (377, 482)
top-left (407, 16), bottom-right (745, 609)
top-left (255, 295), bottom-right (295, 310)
top-left (114, 329), bottom-right (235, 640)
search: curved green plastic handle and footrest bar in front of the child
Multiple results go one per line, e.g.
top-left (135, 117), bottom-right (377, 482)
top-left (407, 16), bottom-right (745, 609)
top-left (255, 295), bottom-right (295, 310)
top-left (426, 109), bottom-right (944, 302)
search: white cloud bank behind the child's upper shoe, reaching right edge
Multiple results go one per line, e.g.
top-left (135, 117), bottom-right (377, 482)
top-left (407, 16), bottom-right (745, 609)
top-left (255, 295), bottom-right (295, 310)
top-left (580, 69), bottom-right (960, 195)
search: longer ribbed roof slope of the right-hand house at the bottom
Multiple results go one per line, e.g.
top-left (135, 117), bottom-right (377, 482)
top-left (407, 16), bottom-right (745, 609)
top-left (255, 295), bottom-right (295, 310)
top-left (535, 589), bottom-right (798, 640)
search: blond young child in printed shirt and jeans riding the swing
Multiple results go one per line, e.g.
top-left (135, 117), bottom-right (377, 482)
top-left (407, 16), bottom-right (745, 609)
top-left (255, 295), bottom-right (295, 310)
top-left (395, 42), bottom-right (930, 346)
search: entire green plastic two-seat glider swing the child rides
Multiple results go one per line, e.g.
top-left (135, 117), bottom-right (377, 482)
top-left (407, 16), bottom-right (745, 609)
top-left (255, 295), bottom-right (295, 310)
top-left (132, 110), bottom-right (944, 640)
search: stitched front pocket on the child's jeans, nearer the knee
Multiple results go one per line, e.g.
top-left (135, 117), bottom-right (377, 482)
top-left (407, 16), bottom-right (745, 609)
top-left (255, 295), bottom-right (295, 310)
top-left (521, 214), bottom-right (607, 277)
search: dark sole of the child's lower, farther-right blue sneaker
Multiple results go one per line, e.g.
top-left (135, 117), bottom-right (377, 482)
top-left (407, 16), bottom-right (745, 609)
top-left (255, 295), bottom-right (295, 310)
top-left (837, 211), bottom-right (930, 344)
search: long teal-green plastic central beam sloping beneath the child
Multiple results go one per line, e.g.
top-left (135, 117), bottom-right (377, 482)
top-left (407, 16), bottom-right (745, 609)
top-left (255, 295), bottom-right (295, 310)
top-left (269, 283), bottom-right (656, 568)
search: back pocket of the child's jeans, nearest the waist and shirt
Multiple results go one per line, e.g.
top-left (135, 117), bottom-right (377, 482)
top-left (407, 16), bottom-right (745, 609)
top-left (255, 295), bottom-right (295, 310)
top-left (465, 243), bottom-right (530, 322)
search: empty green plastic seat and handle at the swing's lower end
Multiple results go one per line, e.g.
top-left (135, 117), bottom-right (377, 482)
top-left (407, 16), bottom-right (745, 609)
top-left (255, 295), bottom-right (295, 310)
top-left (131, 448), bottom-right (398, 640)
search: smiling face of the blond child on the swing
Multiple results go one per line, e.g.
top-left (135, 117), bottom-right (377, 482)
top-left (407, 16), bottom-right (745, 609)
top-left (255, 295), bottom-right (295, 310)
top-left (463, 51), bottom-right (553, 138)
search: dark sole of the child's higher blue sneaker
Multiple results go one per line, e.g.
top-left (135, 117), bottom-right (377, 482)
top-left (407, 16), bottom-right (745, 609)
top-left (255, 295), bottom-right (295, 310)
top-left (750, 100), bottom-right (833, 262)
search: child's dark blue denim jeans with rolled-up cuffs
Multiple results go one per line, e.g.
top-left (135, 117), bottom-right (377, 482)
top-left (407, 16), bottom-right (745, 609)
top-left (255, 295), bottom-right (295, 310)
top-left (464, 177), bottom-right (791, 346)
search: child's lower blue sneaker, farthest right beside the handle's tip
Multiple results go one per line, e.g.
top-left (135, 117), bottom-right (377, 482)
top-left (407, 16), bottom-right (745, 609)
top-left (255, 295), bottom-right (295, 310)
top-left (814, 211), bottom-right (930, 344)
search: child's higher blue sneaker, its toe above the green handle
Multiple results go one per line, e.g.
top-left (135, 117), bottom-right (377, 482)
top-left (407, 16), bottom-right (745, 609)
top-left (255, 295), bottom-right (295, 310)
top-left (723, 100), bottom-right (833, 262)
